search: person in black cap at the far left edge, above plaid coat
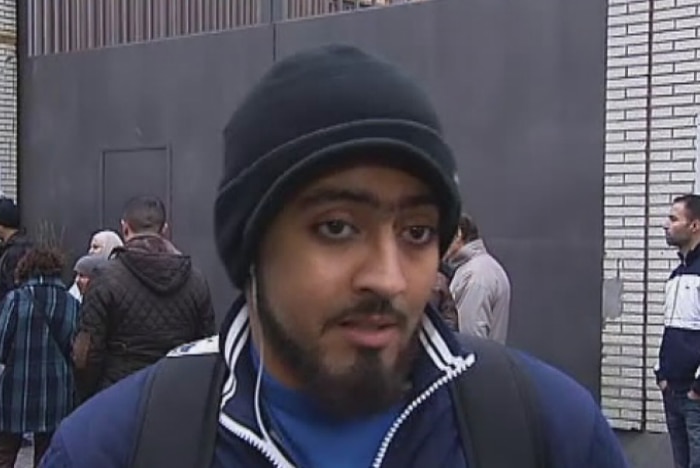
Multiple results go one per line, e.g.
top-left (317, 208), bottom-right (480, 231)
top-left (0, 197), bottom-right (32, 299)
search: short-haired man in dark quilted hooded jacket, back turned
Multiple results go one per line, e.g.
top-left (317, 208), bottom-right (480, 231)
top-left (74, 196), bottom-right (215, 398)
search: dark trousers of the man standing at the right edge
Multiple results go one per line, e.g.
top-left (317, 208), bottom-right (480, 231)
top-left (664, 390), bottom-right (700, 468)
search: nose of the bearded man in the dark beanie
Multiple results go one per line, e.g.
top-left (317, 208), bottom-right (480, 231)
top-left (354, 229), bottom-right (408, 299)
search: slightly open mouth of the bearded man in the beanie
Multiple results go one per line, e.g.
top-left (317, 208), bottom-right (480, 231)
top-left (339, 314), bottom-right (399, 349)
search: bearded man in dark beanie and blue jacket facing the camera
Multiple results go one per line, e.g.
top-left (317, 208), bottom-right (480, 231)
top-left (43, 46), bottom-right (626, 468)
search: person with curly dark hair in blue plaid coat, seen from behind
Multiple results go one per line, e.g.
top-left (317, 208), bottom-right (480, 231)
top-left (0, 247), bottom-right (79, 468)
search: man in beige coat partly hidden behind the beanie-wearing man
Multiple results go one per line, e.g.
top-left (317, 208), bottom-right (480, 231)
top-left (447, 215), bottom-right (510, 343)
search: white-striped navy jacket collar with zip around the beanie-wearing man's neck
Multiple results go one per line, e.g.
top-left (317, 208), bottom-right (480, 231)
top-left (219, 297), bottom-right (476, 467)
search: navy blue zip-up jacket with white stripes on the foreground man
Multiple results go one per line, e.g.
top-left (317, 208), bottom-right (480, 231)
top-left (41, 307), bottom-right (627, 468)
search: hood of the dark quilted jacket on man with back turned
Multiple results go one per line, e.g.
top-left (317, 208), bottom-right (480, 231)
top-left (112, 235), bottom-right (192, 294)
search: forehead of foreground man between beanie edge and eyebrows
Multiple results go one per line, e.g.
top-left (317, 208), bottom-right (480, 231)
top-left (294, 165), bottom-right (435, 209)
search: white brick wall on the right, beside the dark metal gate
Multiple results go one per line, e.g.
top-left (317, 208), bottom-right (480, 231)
top-left (601, 0), bottom-right (700, 431)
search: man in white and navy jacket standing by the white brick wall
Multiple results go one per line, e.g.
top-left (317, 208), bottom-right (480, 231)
top-left (655, 195), bottom-right (700, 468)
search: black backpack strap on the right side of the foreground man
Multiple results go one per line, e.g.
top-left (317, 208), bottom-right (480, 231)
top-left (452, 335), bottom-right (551, 468)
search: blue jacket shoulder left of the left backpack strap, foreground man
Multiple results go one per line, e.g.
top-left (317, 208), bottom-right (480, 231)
top-left (42, 366), bottom-right (154, 468)
